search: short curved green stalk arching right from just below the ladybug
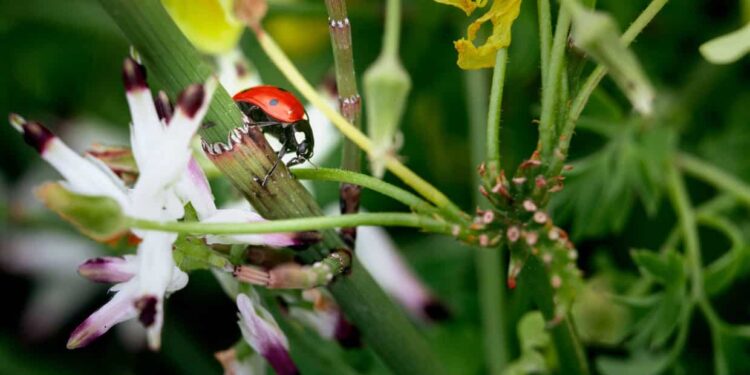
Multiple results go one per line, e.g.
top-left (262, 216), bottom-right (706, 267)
top-left (291, 168), bottom-right (439, 215)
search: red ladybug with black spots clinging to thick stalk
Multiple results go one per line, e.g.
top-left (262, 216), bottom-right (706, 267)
top-left (232, 85), bottom-right (315, 186)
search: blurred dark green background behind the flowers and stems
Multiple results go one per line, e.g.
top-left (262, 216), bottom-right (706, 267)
top-left (0, 0), bottom-right (750, 374)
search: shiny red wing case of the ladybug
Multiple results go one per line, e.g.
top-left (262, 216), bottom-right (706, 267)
top-left (232, 85), bottom-right (305, 123)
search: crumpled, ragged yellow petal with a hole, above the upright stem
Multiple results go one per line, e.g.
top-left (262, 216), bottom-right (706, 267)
top-left (454, 0), bottom-right (521, 70)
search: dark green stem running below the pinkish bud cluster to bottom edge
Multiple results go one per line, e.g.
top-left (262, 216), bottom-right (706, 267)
top-left (519, 256), bottom-right (589, 375)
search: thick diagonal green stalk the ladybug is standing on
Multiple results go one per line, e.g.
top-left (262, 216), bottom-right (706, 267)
top-left (100, 0), bottom-right (450, 374)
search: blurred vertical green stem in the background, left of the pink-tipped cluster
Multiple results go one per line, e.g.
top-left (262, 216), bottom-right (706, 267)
top-left (464, 65), bottom-right (509, 375)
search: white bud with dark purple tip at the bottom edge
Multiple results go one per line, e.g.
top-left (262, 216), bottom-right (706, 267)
top-left (237, 293), bottom-right (299, 375)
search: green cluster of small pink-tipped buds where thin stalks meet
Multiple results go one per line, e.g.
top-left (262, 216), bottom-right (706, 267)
top-left (470, 153), bottom-right (581, 312)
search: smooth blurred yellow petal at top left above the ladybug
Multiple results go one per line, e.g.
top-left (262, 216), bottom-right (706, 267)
top-left (162, 0), bottom-right (244, 54)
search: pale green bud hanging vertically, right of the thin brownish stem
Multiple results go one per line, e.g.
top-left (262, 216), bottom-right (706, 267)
top-left (364, 54), bottom-right (411, 177)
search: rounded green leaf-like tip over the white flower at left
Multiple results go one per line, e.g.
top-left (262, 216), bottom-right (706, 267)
top-left (36, 182), bottom-right (128, 242)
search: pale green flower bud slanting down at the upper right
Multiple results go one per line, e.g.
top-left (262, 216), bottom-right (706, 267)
top-left (563, 0), bottom-right (655, 115)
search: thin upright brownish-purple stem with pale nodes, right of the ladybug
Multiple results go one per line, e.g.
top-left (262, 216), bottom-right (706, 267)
top-left (326, 0), bottom-right (362, 246)
